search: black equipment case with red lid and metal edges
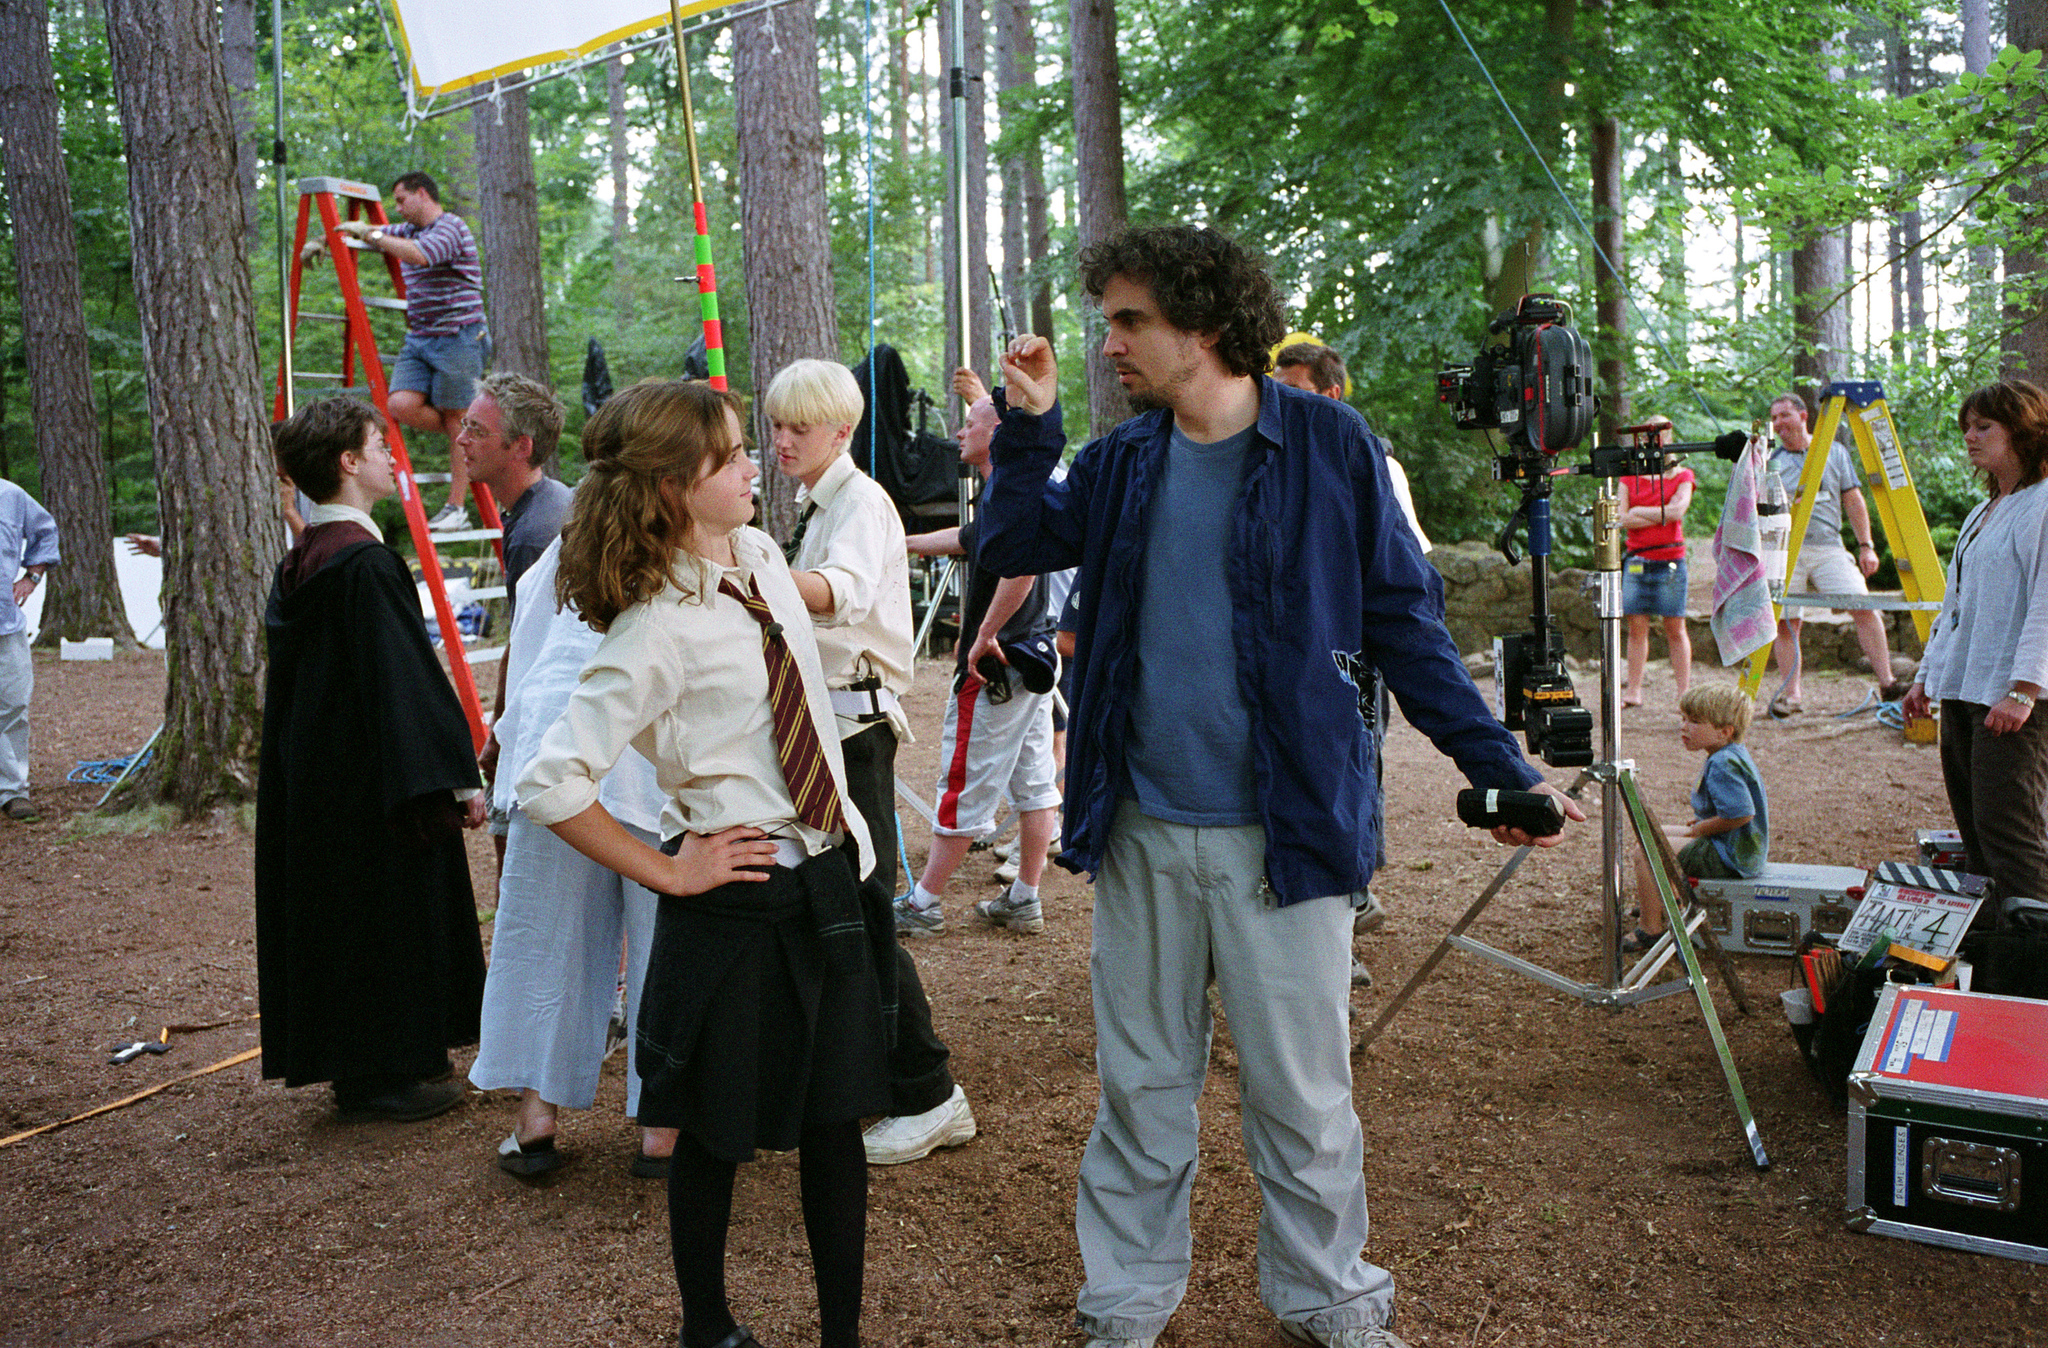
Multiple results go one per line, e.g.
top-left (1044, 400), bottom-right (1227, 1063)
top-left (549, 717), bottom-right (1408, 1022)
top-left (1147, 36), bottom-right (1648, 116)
top-left (1847, 983), bottom-right (2048, 1264)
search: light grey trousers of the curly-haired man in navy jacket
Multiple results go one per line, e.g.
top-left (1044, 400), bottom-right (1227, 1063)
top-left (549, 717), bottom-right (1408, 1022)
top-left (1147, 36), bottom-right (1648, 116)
top-left (1073, 801), bottom-right (1395, 1338)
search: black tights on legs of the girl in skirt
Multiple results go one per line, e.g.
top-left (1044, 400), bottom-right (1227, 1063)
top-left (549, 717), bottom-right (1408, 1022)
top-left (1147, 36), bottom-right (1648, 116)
top-left (668, 1119), bottom-right (868, 1348)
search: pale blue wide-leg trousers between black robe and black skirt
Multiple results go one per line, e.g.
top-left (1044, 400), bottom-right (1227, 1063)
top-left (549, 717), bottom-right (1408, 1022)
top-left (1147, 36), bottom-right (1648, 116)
top-left (469, 811), bottom-right (657, 1117)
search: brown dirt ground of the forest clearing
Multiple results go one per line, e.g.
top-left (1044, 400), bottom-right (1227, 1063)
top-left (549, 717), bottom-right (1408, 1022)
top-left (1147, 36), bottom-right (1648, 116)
top-left (0, 656), bottom-right (2048, 1348)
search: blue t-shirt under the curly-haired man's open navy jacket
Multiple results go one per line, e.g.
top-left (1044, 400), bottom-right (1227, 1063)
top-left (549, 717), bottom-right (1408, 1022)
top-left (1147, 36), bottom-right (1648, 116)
top-left (1126, 426), bottom-right (1260, 828)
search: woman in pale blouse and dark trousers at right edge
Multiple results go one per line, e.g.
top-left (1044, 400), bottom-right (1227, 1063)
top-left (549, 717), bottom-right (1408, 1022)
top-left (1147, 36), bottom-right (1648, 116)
top-left (1905, 379), bottom-right (2048, 914)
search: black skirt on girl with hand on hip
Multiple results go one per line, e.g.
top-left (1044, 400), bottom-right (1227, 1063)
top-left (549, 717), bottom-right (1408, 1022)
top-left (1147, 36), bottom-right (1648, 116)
top-left (635, 848), bottom-right (889, 1162)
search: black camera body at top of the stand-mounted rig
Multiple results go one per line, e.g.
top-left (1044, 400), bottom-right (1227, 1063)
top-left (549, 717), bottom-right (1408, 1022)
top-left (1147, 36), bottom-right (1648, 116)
top-left (1436, 295), bottom-right (1597, 455)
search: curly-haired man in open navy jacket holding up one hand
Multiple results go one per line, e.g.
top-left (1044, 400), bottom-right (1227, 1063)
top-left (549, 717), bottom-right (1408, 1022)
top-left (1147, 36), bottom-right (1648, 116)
top-left (981, 225), bottom-right (1585, 1348)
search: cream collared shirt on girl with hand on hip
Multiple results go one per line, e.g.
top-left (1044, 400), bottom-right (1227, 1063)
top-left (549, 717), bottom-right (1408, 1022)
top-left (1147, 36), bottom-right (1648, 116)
top-left (518, 529), bottom-right (874, 873)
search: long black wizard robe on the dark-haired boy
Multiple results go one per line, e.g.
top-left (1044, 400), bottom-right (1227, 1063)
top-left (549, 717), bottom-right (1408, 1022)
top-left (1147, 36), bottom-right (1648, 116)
top-left (256, 522), bottom-right (483, 1086)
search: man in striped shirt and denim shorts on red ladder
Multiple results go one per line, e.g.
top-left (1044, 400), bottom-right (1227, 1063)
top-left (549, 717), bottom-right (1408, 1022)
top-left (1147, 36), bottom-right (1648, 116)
top-left (340, 170), bottom-right (492, 533)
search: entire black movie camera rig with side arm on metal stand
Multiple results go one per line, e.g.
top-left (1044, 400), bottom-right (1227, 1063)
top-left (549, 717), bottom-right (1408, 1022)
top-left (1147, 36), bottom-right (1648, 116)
top-left (1436, 295), bottom-right (1747, 768)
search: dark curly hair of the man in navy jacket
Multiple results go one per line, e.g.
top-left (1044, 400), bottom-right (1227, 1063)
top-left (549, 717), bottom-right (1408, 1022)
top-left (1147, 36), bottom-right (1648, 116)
top-left (1081, 225), bottom-right (1286, 375)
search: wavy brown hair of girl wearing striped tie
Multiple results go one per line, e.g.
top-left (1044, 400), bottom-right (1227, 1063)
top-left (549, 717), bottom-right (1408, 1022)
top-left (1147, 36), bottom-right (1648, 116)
top-left (555, 379), bottom-right (741, 631)
